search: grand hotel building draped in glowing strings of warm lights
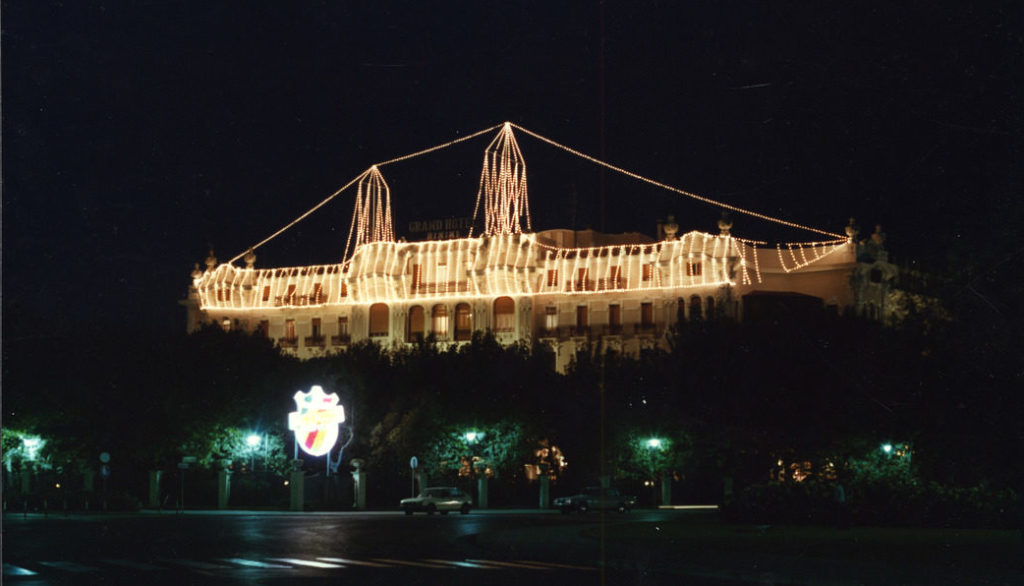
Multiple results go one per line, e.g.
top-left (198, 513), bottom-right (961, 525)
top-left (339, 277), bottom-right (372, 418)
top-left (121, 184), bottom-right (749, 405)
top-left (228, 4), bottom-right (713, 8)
top-left (185, 124), bottom-right (894, 371)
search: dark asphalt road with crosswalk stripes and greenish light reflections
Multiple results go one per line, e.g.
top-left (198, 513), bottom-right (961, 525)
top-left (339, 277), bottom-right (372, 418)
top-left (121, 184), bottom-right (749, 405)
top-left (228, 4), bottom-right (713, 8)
top-left (3, 511), bottom-right (720, 585)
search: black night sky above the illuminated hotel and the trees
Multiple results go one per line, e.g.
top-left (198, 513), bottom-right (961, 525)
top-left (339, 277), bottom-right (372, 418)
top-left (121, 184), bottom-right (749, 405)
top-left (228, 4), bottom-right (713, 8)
top-left (2, 1), bottom-right (1024, 337)
